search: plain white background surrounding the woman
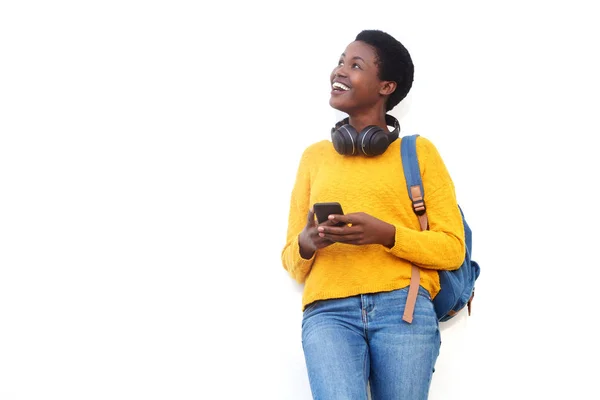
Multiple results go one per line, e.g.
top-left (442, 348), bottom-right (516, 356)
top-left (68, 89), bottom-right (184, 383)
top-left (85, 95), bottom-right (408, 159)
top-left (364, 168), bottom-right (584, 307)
top-left (0, 0), bottom-right (600, 400)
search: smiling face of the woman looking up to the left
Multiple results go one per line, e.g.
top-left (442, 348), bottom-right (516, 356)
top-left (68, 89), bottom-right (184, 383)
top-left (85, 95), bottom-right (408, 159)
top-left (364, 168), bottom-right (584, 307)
top-left (329, 41), bottom-right (383, 114)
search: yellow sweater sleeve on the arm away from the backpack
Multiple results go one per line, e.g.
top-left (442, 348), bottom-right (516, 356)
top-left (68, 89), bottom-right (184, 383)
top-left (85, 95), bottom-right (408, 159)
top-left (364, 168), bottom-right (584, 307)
top-left (281, 149), bottom-right (316, 283)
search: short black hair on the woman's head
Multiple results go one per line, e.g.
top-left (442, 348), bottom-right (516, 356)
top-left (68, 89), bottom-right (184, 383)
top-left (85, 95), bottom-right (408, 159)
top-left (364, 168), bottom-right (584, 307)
top-left (355, 30), bottom-right (415, 111)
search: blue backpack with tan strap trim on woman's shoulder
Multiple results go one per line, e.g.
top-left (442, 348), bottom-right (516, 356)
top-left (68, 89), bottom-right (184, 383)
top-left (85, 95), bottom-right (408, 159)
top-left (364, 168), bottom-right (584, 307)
top-left (400, 135), bottom-right (479, 323)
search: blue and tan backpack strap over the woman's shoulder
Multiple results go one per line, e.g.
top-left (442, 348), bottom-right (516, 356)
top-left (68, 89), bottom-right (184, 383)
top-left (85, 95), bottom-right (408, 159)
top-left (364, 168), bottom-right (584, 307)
top-left (400, 135), bottom-right (429, 324)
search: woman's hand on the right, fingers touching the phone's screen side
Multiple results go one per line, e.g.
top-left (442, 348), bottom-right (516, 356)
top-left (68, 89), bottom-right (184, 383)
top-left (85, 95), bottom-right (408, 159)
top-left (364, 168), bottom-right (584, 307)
top-left (317, 212), bottom-right (396, 248)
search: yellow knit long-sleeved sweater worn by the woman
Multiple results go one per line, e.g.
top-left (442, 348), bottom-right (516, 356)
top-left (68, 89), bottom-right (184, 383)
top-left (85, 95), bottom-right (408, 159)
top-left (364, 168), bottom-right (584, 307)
top-left (281, 136), bottom-right (465, 310)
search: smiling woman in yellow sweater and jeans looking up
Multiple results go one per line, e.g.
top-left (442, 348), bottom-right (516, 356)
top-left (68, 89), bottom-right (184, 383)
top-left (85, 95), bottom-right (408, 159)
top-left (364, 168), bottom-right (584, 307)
top-left (281, 30), bottom-right (465, 400)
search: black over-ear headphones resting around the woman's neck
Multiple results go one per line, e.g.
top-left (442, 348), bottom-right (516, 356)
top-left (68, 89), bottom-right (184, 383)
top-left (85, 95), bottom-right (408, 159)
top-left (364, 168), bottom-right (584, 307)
top-left (331, 114), bottom-right (400, 156)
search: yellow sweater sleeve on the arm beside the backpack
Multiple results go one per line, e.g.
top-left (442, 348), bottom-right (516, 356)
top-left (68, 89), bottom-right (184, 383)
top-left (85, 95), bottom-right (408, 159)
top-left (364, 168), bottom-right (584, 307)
top-left (387, 137), bottom-right (465, 270)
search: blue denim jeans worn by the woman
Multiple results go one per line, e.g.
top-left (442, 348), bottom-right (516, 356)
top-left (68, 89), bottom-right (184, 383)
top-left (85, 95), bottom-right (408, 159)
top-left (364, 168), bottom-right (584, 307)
top-left (302, 287), bottom-right (441, 400)
